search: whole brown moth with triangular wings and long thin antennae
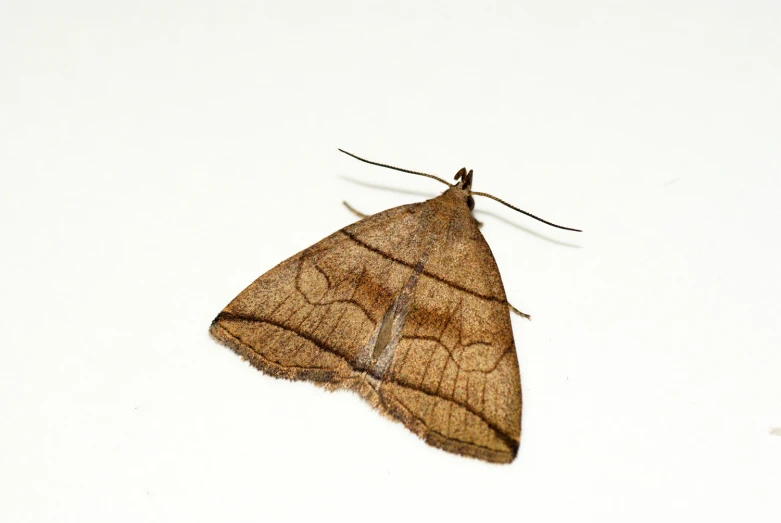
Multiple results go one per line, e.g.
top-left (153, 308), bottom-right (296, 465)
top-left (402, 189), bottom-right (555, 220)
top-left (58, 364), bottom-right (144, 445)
top-left (210, 151), bottom-right (577, 463)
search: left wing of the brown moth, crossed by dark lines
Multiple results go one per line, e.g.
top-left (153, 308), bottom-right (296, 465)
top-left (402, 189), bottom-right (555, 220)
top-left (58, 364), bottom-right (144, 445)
top-left (210, 204), bottom-right (424, 387)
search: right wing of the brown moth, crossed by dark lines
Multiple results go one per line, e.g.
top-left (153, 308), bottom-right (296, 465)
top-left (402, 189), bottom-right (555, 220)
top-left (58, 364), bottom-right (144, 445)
top-left (348, 201), bottom-right (522, 463)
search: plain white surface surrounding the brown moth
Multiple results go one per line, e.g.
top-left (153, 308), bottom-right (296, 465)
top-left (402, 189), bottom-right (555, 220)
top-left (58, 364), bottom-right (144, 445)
top-left (0, 0), bottom-right (781, 522)
